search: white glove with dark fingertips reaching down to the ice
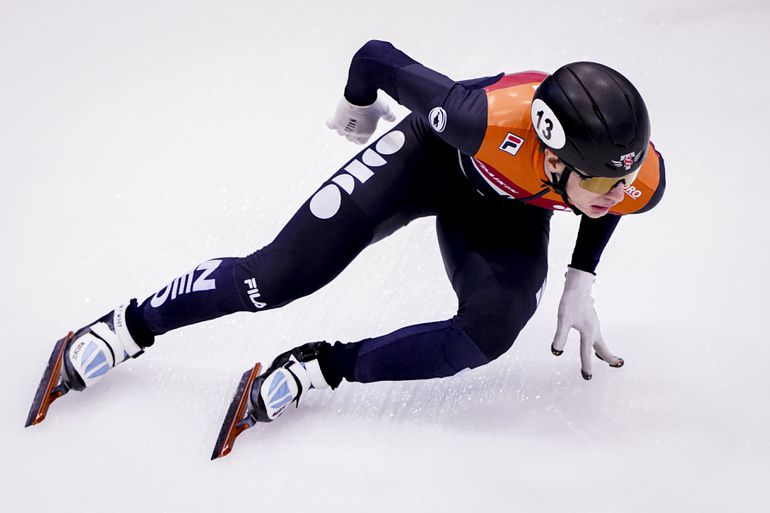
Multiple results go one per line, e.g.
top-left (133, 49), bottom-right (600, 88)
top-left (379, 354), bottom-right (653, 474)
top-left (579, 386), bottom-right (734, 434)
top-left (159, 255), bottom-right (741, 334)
top-left (551, 267), bottom-right (624, 380)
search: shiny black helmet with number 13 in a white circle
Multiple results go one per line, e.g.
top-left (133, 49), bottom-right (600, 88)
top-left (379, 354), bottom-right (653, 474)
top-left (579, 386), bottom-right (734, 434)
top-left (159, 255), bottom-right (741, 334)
top-left (532, 62), bottom-right (650, 177)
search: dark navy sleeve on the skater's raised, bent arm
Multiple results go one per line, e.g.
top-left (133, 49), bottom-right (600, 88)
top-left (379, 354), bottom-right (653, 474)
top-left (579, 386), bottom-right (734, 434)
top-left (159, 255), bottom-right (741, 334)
top-left (345, 41), bottom-right (502, 155)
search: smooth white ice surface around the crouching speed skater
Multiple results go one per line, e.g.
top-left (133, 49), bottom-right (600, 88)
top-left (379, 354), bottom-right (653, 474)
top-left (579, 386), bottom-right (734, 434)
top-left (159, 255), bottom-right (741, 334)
top-left (0, 0), bottom-right (770, 513)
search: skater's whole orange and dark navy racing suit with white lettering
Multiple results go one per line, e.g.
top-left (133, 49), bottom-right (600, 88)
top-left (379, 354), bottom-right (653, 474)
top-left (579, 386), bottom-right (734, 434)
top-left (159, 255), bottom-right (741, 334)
top-left (127, 41), bottom-right (665, 387)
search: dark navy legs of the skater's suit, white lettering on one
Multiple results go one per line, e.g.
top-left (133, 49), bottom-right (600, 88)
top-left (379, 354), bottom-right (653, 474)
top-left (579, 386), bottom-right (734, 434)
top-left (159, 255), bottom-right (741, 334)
top-left (132, 115), bottom-right (552, 386)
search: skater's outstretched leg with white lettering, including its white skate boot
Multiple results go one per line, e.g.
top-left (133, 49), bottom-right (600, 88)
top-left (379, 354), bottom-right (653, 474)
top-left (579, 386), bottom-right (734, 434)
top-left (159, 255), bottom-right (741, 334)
top-left (64, 116), bottom-right (460, 388)
